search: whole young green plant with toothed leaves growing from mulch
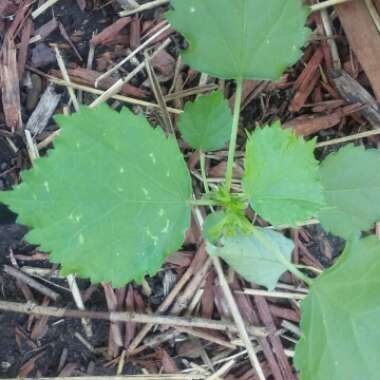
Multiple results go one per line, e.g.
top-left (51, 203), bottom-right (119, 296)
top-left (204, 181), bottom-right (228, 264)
top-left (0, 0), bottom-right (380, 380)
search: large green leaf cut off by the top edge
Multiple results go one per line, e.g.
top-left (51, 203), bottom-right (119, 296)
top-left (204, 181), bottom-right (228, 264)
top-left (166, 0), bottom-right (310, 80)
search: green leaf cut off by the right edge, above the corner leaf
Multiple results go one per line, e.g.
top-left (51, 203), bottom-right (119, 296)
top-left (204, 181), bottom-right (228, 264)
top-left (319, 145), bottom-right (380, 238)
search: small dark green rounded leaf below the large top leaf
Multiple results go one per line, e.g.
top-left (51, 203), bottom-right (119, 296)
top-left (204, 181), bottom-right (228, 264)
top-left (178, 91), bottom-right (232, 151)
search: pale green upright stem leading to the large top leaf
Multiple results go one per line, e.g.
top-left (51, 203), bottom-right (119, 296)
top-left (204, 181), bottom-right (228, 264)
top-left (226, 78), bottom-right (243, 192)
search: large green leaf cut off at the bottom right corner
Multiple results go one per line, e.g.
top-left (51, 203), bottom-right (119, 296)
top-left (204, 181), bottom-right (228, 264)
top-left (295, 236), bottom-right (380, 380)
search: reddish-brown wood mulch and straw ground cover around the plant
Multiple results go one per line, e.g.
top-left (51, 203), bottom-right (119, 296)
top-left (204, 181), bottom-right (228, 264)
top-left (0, 0), bottom-right (380, 380)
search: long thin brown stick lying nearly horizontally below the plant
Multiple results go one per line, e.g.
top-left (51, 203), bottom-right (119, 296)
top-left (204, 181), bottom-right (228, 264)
top-left (0, 301), bottom-right (263, 336)
